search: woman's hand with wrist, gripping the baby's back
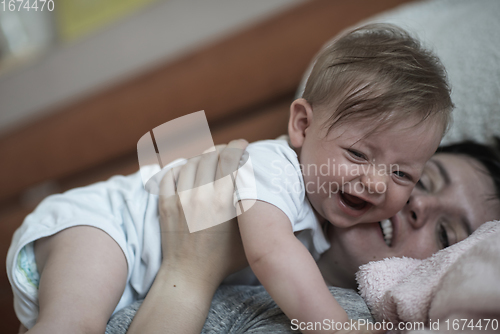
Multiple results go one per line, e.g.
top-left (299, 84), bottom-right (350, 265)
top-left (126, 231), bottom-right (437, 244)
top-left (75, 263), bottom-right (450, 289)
top-left (159, 140), bottom-right (248, 287)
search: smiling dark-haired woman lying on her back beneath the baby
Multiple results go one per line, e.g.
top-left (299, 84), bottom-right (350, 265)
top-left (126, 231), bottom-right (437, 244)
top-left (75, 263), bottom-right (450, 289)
top-left (108, 137), bottom-right (500, 333)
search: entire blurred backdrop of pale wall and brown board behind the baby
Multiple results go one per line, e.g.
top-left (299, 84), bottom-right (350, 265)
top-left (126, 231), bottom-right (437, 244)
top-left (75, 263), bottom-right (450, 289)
top-left (0, 0), bottom-right (408, 333)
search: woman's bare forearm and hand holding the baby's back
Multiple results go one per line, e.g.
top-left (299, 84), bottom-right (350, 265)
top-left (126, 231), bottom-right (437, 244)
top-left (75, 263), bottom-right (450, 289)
top-left (128, 140), bottom-right (248, 333)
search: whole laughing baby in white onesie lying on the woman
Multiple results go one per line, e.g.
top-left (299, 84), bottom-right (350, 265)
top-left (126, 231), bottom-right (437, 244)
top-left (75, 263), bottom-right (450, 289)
top-left (7, 25), bottom-right (452, 333)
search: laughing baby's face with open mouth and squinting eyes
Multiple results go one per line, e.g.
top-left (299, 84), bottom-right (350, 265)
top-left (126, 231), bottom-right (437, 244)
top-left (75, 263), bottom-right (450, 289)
top-left (300, 114), bottom-right (442, 227)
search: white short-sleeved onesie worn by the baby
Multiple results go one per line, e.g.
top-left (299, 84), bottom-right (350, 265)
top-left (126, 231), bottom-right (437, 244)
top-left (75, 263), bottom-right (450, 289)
top-left (7, 137), bottom-right (330, 329)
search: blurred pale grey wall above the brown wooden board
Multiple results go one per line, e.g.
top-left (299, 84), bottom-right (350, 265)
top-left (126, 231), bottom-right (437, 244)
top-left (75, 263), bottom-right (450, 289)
top-left (0, 0), bottom-right (303, 135)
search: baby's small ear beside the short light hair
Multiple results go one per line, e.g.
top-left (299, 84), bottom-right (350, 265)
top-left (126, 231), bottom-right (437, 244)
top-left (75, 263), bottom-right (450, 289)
top-left (288, 98), bottom-right (312, 148)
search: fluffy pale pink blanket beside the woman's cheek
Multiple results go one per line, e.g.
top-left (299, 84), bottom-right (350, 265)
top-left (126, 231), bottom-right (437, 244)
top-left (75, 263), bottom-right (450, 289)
top-left (356, 221), bottom-right (500, 333)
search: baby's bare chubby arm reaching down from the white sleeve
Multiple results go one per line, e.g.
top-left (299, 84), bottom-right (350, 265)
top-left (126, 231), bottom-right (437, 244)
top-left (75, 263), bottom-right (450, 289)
top-left (238, 201), bottom-right (348, 333)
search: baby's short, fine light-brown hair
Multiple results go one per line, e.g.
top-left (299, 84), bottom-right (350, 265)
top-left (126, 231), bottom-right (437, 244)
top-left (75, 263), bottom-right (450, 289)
top-left (302, 24), bottom-right (453, 135)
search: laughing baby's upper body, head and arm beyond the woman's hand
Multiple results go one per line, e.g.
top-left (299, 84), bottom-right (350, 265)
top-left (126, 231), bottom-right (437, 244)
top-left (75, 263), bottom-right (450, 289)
top-left (232, 25), bottom-right (452, 333)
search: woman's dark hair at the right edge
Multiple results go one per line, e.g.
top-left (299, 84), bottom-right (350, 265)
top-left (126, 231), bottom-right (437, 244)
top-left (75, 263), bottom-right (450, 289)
top-left (436, 137), bottom-right (500, 199)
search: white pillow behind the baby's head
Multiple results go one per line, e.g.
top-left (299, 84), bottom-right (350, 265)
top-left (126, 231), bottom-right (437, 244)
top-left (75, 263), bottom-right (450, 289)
top-left (299, 0), bottom-right (500, 144)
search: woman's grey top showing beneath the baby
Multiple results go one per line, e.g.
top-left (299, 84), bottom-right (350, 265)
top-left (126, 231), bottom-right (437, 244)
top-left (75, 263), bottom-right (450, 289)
top-left (106, 285), bottom-right (373, 334)
